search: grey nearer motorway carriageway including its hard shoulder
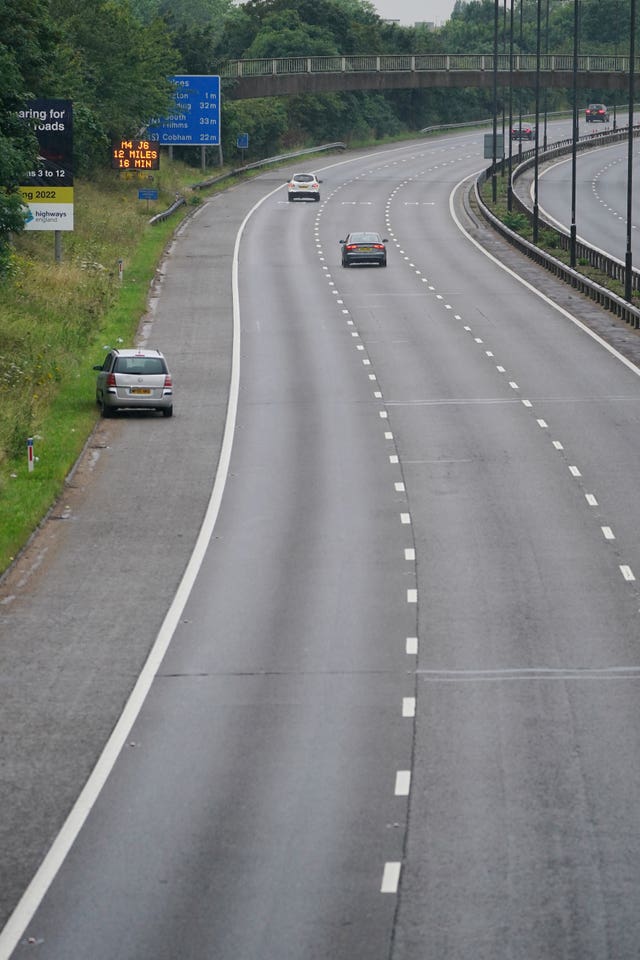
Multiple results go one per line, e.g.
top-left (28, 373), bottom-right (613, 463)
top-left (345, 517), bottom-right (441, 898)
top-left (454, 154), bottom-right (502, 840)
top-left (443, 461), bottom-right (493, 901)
top-left (0, 133), bottom-right (640, 960)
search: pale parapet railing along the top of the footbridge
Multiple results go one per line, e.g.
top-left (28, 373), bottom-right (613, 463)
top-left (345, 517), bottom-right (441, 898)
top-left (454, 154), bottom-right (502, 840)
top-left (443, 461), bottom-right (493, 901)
top-left (218, 53), bottom-right (640, 79)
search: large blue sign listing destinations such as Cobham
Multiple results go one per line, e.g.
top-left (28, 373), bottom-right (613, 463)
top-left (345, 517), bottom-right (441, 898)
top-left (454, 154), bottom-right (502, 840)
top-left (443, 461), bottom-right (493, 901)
top-left (147, 74), bottom-right (220, 147)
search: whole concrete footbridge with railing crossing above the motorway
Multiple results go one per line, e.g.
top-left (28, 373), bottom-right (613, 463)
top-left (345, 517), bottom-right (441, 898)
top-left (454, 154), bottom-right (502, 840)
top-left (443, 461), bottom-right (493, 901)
top-left (216, 53), bottom-right (640, 100)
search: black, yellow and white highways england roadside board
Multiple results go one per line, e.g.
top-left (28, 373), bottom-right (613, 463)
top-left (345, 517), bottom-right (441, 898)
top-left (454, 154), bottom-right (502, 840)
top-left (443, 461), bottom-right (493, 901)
top-left (18, 99), bottom-right (73, 230)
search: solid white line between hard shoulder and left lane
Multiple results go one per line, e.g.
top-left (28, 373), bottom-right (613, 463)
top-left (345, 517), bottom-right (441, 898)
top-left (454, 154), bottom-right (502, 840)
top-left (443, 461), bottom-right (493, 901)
top-left (0, 180), bottom-right (281, 960)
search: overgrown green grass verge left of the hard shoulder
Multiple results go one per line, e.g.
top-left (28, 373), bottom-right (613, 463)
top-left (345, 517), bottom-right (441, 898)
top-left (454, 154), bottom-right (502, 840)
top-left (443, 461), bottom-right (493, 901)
top-left (0, 163), bottom-right (206, 572)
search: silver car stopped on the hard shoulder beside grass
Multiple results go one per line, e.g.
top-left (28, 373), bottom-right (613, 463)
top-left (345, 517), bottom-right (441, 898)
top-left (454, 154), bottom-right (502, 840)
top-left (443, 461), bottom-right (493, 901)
top-left (93, 349), bottom-right (173, 417)
